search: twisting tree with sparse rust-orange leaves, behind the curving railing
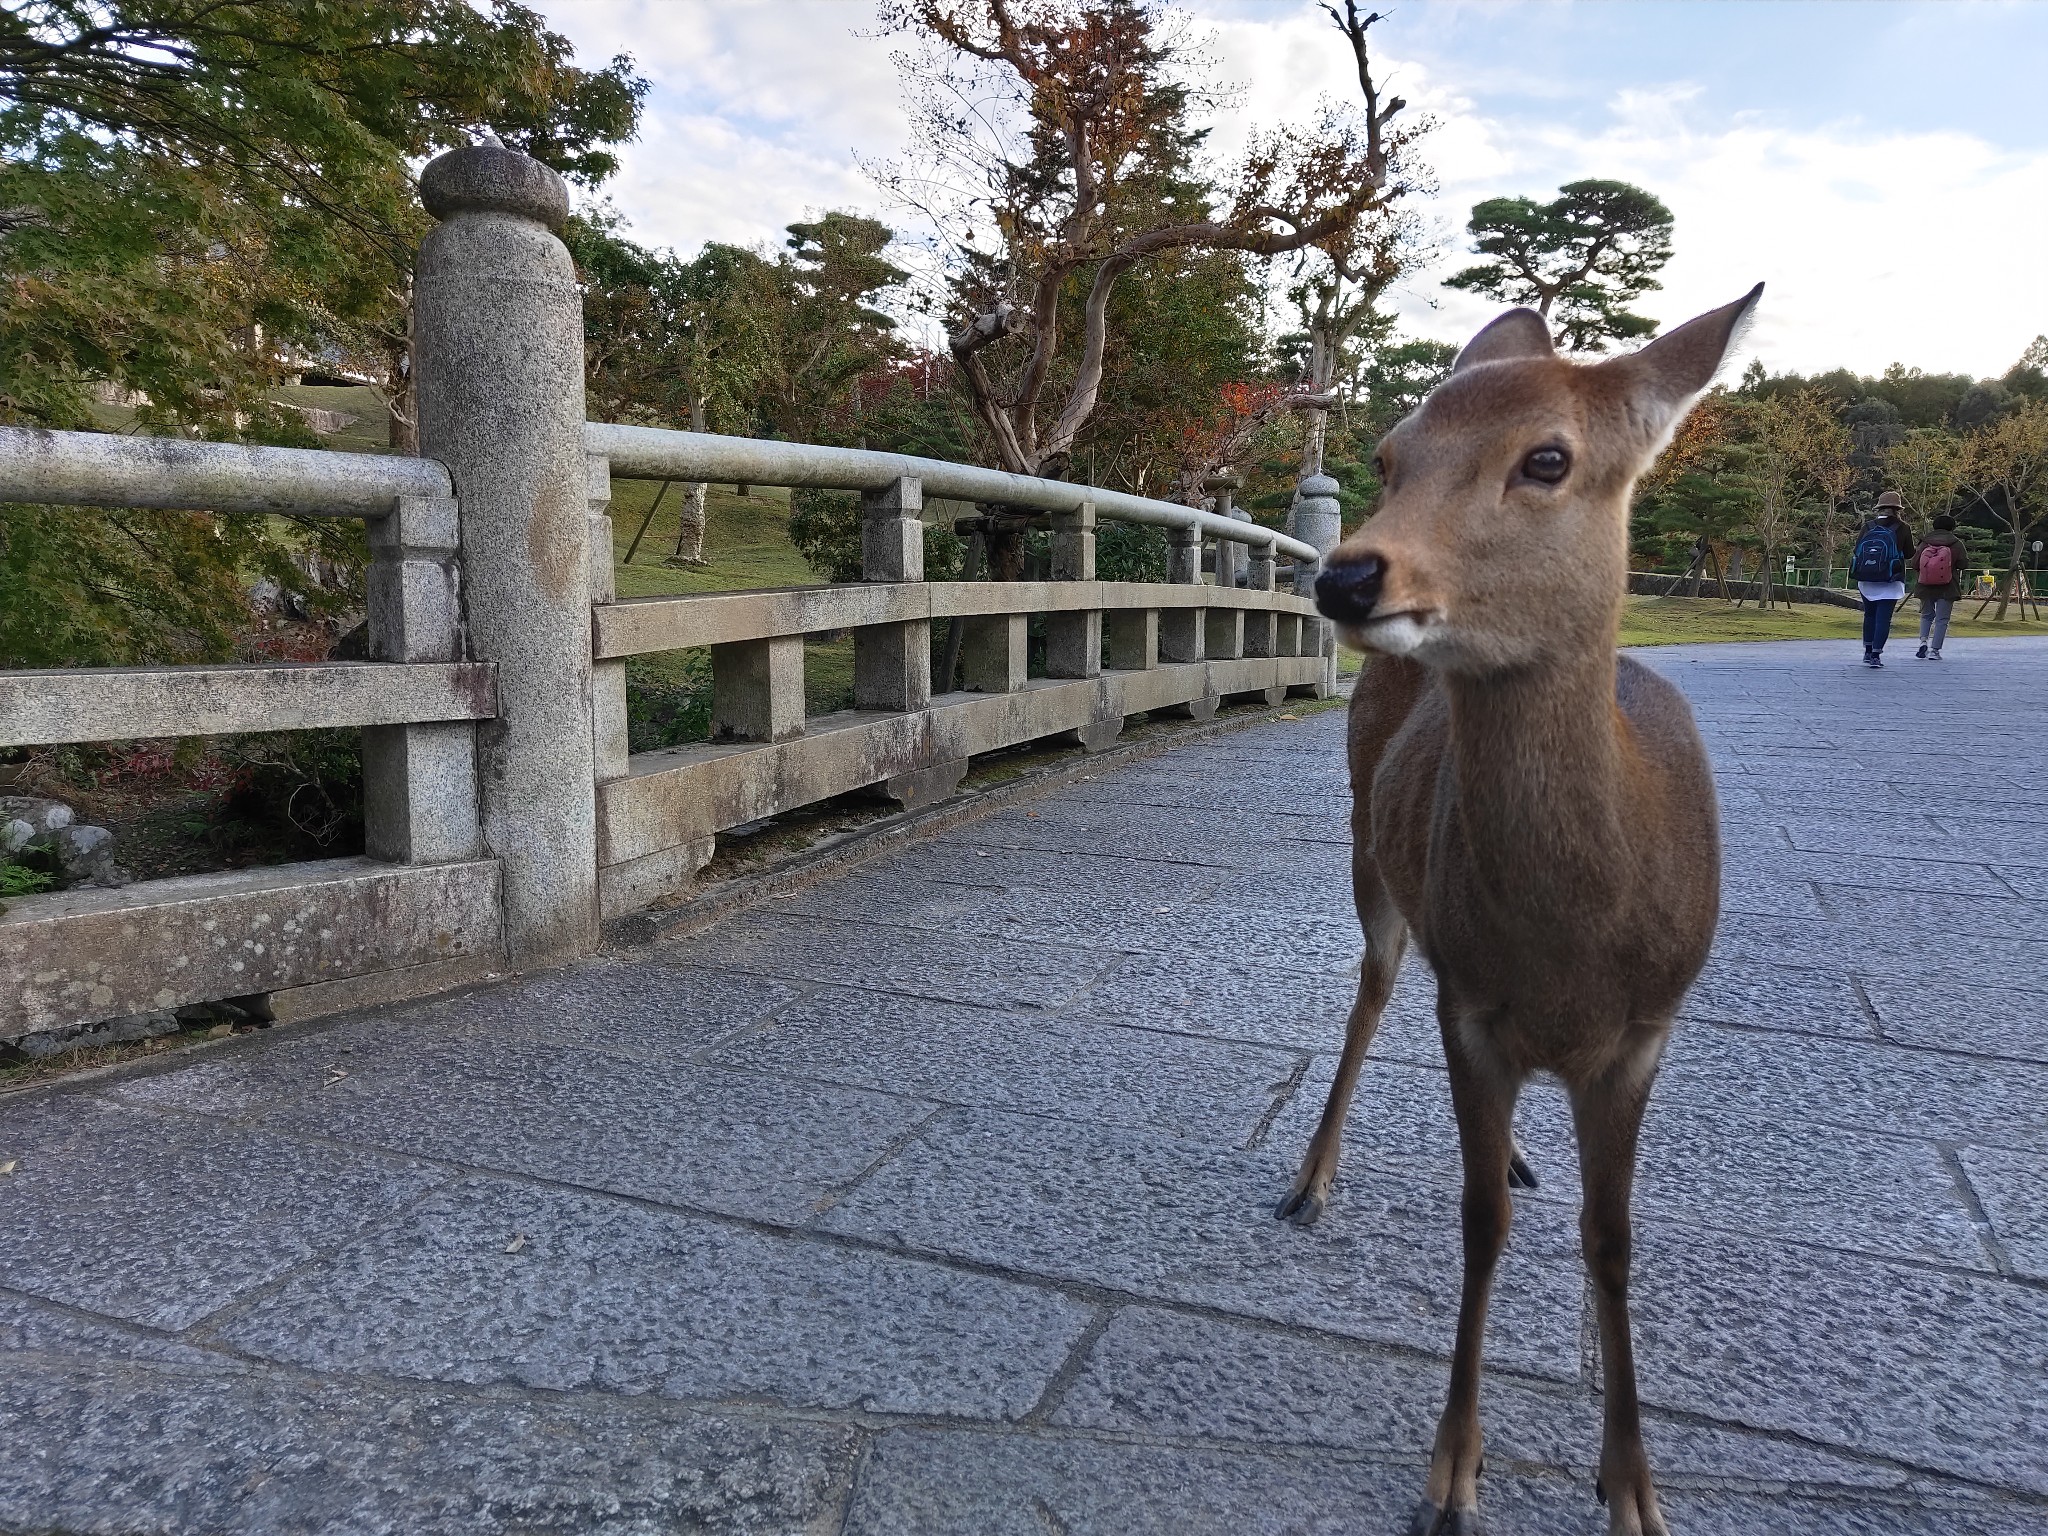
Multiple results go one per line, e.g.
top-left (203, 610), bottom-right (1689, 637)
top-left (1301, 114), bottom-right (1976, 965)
top-left (883, 0), bottom-right (1384, 505)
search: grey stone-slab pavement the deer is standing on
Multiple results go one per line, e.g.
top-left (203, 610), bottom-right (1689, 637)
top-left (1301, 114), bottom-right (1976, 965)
top-left (0, 641), bottom-right (2048, 1536)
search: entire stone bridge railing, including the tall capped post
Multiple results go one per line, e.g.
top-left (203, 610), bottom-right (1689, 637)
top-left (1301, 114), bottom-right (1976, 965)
top-left (0, 145), bottom-right (1335, 1040)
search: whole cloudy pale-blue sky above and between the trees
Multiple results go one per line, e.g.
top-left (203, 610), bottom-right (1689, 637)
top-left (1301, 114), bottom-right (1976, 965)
top-left (539, 0), bottom-right (2048, 377)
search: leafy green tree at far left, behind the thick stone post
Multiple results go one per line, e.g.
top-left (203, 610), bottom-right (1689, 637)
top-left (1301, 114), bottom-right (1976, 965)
top-left (0, 0), bottom-right (643, 666)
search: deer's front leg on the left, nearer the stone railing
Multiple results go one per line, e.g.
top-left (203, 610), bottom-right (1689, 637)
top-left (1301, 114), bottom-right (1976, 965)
top-left (1409, 1024), bottom-right (1518, 1536)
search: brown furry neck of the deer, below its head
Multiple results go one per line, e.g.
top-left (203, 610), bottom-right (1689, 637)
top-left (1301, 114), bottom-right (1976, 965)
top-left (1446, 647), bottom-right (1628, 928)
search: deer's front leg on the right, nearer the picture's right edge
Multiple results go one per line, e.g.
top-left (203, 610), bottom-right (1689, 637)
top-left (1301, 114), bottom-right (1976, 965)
top-left (1571, 1034), bottom-right (1669, 1536)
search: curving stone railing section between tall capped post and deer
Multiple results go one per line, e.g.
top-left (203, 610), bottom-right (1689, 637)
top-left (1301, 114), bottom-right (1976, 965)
top-left (584, 426), bottom-right (1335, 918)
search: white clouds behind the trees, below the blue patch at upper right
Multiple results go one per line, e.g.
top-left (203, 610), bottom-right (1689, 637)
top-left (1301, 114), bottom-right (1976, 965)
top-left (545, 0), bottom-right (2048, 375)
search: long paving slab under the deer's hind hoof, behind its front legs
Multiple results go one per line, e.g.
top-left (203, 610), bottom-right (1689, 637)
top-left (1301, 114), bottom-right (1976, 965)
top-left (819, 1110), bottom-right (1581, 1380)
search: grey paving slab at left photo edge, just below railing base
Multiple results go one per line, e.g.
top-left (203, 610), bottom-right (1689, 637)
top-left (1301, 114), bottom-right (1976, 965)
top-left (0, 1094), bottom-right (446, 1329)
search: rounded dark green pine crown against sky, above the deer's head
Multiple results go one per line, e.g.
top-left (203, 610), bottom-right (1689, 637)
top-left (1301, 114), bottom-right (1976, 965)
top-left (1444, 180), bottom-right (1671, 352)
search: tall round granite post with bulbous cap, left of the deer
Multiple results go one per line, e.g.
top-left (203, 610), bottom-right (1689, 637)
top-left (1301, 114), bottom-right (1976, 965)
top-left (414, 145), bottom-right (598, 969)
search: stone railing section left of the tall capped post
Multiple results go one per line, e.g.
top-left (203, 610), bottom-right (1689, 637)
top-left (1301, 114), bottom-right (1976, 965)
top-left (0, 428), bottom-right (504, 1040)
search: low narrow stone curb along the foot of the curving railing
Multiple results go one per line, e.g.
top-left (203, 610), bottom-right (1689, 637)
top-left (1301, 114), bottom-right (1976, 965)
top-left (604, 674), bottom-right (1356, 954)
